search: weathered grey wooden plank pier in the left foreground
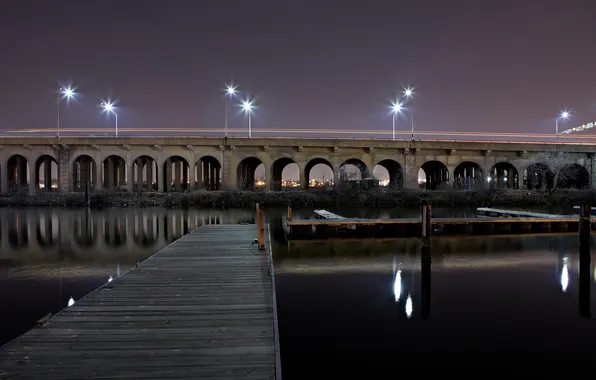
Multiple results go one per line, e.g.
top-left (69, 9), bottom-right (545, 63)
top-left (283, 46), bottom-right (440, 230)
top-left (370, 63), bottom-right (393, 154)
top-left (0, 224), bottom-right (281, 380)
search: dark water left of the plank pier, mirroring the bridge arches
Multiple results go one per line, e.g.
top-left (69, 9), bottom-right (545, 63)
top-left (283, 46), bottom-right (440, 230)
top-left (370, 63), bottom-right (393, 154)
top-left (0, 208), bottom-right (254, 344)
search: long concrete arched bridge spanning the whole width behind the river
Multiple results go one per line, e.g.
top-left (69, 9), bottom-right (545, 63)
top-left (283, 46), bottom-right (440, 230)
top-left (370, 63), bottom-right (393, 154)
top-left (0, 137), bottom-right (596, 194)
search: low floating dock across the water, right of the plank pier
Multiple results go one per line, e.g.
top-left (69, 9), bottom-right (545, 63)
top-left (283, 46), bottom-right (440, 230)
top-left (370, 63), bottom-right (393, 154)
top-left (281, 208), bottom-right (593, 240)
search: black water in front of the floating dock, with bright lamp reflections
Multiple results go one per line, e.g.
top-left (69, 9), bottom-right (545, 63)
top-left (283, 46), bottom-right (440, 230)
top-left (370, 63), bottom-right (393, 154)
top-left (274, 236), bottom-right (596, 380)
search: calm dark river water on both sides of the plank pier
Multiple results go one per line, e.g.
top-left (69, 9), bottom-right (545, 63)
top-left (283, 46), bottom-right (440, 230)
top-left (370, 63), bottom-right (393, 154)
top-left (0, 209), bottom-right (596, 380)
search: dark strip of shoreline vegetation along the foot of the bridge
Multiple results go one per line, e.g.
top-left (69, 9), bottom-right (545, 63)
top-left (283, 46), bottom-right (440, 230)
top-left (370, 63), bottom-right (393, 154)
top-left (0, 188), bottom-right (596, 209)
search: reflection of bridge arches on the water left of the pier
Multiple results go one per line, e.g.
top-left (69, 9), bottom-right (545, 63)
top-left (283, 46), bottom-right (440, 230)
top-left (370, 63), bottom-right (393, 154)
top-left (0, 209), bottom-right (254, 262)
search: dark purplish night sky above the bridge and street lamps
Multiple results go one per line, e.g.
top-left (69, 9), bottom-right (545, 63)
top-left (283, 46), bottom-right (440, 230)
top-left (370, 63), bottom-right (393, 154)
top-left (0, 0), bottom-right (596, 181)
